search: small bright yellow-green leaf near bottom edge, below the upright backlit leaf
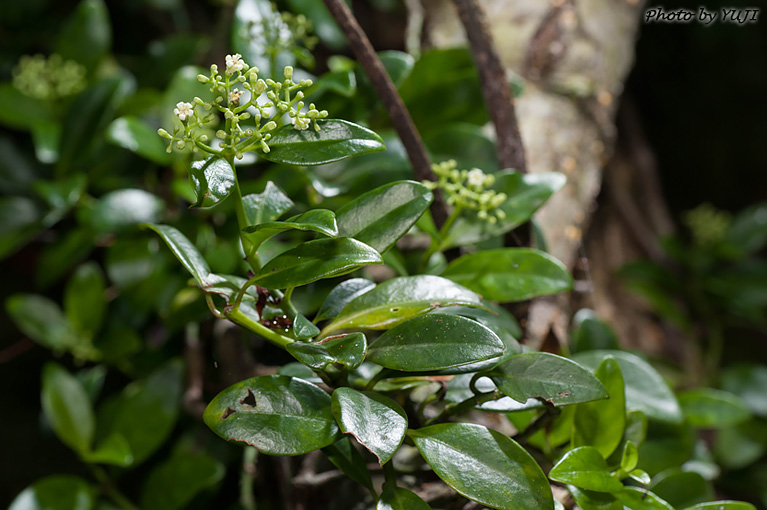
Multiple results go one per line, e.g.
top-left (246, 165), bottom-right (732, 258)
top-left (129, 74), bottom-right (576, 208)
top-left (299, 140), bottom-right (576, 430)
top-left (549, 446), bottom-right (623, 492)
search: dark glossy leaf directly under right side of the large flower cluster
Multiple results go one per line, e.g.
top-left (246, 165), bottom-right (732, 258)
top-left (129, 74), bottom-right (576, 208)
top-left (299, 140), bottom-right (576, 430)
top-left (261, 119), bottom-right (386, 166)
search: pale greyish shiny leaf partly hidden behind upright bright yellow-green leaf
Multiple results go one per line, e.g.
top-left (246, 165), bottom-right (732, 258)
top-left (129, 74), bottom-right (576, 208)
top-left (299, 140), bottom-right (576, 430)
top-left (573, 350), bottom-right (682, 423)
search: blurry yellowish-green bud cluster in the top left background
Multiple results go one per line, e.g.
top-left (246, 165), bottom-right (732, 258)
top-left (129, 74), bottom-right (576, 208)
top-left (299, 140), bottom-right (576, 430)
top-left (13, 53), bottom-right (87, 100)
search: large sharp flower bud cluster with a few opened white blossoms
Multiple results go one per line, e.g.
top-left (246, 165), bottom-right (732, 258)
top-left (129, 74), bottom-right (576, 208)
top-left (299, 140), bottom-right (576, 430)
top-left (158, 53), bottom-right (328, 159)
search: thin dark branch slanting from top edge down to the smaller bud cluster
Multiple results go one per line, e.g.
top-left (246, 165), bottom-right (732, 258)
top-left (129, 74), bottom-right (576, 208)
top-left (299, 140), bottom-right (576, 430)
top-left (323, 0), bottom-right (447, 228)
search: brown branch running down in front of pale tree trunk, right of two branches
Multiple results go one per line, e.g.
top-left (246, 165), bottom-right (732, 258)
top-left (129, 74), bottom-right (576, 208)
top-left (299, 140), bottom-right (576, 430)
top-left (453, 0), bottom-right (527, 172)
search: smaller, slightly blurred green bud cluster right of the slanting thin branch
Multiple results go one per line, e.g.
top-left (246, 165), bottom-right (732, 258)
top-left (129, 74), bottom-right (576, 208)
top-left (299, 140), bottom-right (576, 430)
top-left (424, 159), bottom-right (508, 223)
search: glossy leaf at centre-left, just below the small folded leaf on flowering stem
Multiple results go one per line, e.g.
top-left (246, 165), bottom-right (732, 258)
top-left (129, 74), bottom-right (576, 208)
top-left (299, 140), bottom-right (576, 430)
top-left (256, 237), bottom-right (383, 289)
